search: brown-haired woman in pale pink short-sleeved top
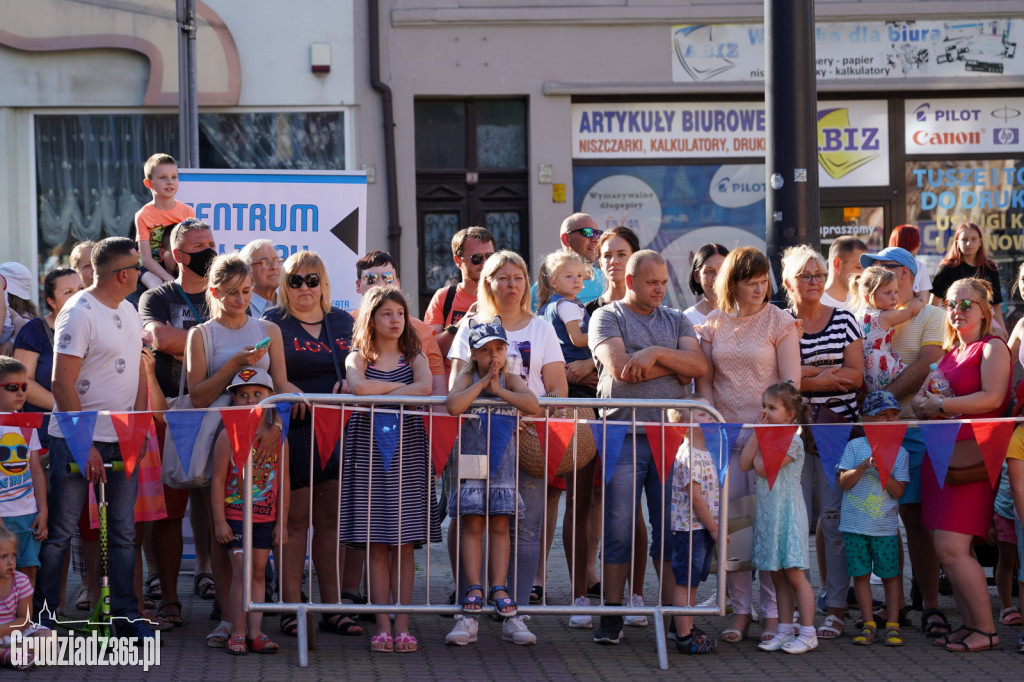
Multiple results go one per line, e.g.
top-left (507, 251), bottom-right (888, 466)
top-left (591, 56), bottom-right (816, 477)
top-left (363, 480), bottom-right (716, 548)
top-left (697, 247), bottom-right (801, 642)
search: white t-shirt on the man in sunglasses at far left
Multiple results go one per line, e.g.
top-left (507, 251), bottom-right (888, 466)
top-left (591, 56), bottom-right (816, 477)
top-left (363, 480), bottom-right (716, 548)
top-left (49, 291), bottom-right (142, 442)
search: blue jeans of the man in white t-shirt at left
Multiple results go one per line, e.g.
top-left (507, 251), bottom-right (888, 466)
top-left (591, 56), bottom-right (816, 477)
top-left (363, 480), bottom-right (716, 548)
top-left (35, 436), bottom-right (138, 617)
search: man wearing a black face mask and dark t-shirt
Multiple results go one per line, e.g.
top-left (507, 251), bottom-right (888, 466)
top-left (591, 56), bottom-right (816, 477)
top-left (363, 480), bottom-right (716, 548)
top-left (138, 218), bottom-right (217, 625)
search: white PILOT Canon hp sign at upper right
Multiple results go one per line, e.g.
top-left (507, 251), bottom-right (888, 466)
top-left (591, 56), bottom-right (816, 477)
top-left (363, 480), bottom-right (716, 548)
top-left (904, 97), bottom-right (1024, 155)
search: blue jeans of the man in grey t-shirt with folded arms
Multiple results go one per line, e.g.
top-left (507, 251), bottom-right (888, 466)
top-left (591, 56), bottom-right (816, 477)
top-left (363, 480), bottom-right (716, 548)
top-left (598, 433), bottom-right (675, 563)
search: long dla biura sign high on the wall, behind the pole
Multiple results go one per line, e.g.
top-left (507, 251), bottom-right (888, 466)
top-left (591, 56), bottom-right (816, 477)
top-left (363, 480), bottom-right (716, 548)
top-left (672, 18), bottom-right (1024, 83)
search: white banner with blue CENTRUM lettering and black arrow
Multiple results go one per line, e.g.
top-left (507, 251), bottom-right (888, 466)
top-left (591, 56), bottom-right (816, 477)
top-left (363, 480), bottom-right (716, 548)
top-left (177, 168), bottom-right (367, 310)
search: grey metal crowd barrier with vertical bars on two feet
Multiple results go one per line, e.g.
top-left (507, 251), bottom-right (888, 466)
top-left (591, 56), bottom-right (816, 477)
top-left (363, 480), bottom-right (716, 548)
top-left (243, 393), bottom-right (729, 670)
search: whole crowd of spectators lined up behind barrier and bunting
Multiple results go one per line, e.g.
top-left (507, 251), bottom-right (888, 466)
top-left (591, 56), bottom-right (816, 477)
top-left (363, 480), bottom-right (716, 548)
top-left (0, 155), bottom-right (1024, 654)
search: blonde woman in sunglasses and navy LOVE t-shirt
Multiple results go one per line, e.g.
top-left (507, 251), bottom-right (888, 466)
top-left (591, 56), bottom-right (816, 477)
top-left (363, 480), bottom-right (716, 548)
top-left (264, 251), bottom-right (362, 637)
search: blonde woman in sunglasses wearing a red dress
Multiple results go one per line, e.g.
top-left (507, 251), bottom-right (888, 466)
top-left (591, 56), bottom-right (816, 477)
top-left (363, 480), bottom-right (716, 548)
top-left (913, 278), bottom-right (1013, 651)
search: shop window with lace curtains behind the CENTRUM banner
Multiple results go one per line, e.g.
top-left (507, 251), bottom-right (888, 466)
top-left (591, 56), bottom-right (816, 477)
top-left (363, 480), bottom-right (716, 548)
top-left (35, 112), bottom-right (345, 259)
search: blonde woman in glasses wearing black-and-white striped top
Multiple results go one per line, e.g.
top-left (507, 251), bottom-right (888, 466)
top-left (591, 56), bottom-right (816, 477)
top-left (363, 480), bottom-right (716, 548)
top-left (782, 245), bottom-right (864, 639)
